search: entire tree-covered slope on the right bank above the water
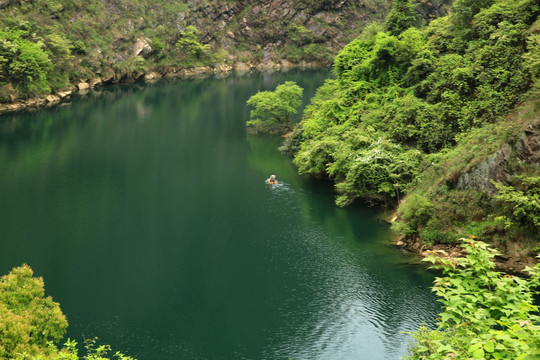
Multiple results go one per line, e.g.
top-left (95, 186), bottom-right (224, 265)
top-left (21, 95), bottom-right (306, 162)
top-left (284, 0), bottom-right (540, 264)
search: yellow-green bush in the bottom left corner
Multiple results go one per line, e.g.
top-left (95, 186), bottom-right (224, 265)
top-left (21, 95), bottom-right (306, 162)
top-left (0, 265), bottom-right (133, 360)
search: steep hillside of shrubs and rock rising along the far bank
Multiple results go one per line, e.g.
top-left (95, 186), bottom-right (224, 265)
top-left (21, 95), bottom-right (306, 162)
top-left (0, 0), bottom-right (450, 109)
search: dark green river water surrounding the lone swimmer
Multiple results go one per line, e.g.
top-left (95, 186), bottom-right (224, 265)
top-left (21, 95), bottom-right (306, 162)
top-left (0, 71), bottom-right (438, 360)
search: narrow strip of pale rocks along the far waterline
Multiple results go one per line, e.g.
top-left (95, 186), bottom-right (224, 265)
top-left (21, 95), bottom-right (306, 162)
top-left (0, 60), bottom-right (328, 115)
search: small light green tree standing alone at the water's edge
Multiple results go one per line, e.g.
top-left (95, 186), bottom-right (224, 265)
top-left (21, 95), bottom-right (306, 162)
top-left (246, 81), bottom-right (304, 133)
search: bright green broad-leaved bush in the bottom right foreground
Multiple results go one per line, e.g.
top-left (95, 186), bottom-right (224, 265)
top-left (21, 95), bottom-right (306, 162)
top-left (408, 238), bottom-right (540, 360)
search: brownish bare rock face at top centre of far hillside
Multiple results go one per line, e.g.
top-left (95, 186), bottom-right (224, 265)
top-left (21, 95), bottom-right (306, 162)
top-left (182, 0), bottom-right (392, 62)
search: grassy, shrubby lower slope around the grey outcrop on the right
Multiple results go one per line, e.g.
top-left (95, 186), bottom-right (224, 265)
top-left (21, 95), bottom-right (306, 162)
top-left (392, 91), bottom-right (540, 250)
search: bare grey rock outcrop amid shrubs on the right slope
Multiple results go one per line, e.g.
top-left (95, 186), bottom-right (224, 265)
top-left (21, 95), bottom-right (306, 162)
top-left (456, 144), bottom-right (512, 196)
